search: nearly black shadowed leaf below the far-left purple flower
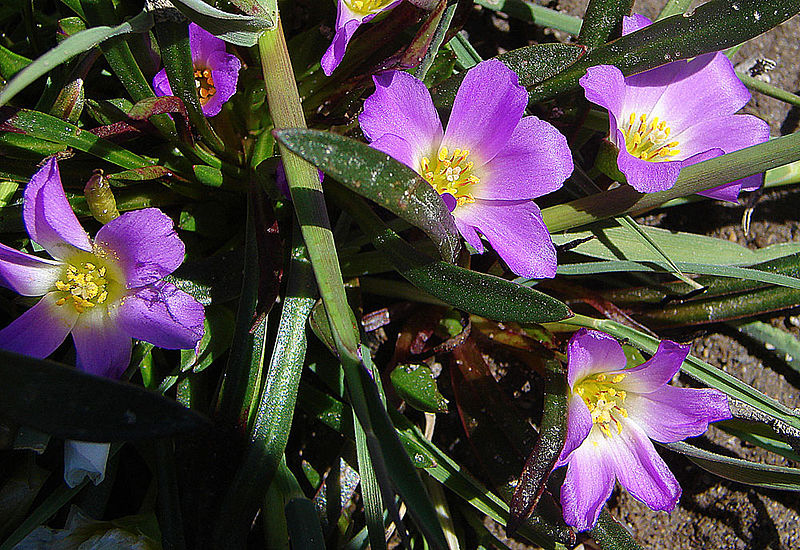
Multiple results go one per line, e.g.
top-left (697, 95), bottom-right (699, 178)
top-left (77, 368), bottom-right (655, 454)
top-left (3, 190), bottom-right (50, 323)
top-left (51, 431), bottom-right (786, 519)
top-left (0, 351), bottom-right (210, 441)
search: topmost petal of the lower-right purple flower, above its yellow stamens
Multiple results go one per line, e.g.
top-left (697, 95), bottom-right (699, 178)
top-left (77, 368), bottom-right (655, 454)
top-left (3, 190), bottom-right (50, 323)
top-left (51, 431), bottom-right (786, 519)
top-left (567, 328), bottom-right (627, 388)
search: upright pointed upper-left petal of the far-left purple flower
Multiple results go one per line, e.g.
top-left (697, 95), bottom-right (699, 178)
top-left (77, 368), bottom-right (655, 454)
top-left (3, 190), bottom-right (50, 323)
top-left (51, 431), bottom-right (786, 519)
top-left (22, 157), bottom-right (92, 259)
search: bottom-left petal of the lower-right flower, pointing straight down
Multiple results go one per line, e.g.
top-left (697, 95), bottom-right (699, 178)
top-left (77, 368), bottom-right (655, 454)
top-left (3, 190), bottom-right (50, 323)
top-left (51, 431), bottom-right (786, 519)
top-left (561, 430), bottom-right (614, 532)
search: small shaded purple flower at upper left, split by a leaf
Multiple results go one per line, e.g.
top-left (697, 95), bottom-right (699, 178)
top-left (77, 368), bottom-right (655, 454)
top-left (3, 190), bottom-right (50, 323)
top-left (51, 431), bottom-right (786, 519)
top-left (153, 23), bottom-right (242, 116)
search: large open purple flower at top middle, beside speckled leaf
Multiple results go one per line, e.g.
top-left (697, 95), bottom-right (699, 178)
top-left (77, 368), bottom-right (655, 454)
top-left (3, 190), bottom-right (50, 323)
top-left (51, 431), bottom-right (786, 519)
top-left (358, 60), bottom-right (572, 277)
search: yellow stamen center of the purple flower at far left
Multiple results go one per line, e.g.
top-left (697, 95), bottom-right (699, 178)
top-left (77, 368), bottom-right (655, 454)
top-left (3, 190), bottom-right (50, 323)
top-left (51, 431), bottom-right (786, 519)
top-left (55, 251), bottom-right (122, 313)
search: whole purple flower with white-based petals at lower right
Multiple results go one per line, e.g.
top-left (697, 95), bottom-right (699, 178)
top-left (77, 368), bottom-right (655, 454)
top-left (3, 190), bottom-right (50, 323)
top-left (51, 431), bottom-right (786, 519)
top-left (556, 329), bottom-right (731, 531)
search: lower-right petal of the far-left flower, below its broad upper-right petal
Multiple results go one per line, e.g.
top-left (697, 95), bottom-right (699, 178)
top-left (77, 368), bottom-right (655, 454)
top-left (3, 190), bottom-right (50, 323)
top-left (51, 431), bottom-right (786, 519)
top-left (117, 281), bottom-right (204, 349)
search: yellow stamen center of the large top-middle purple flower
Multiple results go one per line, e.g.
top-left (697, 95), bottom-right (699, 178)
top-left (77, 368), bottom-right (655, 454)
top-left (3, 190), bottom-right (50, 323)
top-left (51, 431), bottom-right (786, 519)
top-left (419, 146), bottom-right (481, 210)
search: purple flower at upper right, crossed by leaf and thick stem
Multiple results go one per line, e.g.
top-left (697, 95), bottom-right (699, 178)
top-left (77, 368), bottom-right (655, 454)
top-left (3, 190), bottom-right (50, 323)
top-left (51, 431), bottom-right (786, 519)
top-left (580, 15), bottom-right (769, 202)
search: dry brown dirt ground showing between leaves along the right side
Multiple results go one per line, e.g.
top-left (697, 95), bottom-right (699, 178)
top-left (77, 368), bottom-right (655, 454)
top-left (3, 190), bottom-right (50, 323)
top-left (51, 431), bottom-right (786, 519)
top-left (466, 0), bottom-right (800, 550)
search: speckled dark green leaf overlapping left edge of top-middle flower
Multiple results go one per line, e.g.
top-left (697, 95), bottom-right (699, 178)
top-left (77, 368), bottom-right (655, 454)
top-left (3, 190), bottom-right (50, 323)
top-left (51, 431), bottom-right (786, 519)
top-left (275, 128), bottom-right (460, 268)
